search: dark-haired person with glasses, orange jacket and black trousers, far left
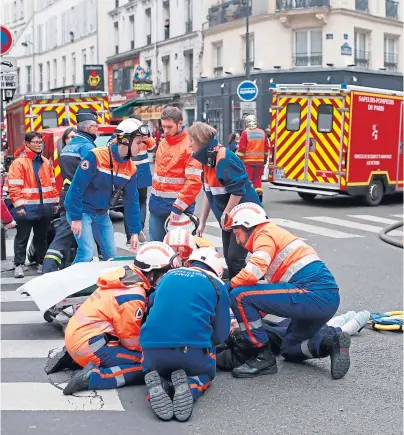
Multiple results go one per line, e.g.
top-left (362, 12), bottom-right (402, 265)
top-left (7, 132), bottom-right (59, 278)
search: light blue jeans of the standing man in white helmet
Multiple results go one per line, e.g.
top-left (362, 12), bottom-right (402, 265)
top-left (66, 213), bottom-right (117, 264)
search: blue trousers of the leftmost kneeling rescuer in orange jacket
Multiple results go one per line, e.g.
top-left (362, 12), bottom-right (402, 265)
top-left (89, 342), bottom-right (144, 390)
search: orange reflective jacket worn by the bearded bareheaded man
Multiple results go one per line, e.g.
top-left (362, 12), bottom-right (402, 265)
top-left (149, 130), bottom-right (202, 214)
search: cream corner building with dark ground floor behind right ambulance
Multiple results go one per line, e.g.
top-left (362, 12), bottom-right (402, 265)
top-left (198, 0), bottom-right (403, 141)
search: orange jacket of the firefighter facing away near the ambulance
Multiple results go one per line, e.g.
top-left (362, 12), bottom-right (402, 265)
top-left (237, 128), bottom-right (269, 165)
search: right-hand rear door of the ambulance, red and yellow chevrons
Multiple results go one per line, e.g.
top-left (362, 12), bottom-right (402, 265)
top-left (304, 94), bottom-right (348, 189)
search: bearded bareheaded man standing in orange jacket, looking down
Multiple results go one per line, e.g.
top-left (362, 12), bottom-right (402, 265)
top-left (149, 107), bottom-right (202, 242)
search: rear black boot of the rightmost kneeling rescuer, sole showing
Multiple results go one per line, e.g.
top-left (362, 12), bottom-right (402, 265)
top-left (321, 332), bottom-right (351, 379)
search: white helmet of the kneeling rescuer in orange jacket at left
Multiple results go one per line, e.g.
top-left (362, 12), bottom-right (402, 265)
top-left (134, 242), bottom-right (181, 272)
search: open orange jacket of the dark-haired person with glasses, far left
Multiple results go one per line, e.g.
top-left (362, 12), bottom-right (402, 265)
top-left (7, 147), bottom-right (59, 219)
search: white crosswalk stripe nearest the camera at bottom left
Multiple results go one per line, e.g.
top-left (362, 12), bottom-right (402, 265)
top-left (1, 382), bottom-right (125, 411)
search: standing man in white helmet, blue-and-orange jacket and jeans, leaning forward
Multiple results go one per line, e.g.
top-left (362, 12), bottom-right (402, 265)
top-left (64, 119), bottom-right (148, 264)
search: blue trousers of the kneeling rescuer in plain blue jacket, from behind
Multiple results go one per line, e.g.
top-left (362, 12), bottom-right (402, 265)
top-left (143, 347), bottom-right (216, 401)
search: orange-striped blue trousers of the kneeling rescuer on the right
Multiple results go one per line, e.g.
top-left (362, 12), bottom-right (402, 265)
top-left (230, 283), bottom-right (340, 361)
